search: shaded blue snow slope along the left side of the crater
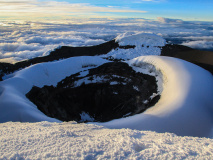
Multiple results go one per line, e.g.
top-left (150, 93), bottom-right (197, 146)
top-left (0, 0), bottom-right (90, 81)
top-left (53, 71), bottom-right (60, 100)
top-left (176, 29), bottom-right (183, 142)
top-left (0, 57), bottom-right (108, 123)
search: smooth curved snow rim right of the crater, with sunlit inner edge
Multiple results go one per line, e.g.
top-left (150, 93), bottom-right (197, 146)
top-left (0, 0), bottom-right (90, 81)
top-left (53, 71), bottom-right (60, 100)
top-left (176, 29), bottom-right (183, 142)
top-left (95, 56), bottom-right (213, 136)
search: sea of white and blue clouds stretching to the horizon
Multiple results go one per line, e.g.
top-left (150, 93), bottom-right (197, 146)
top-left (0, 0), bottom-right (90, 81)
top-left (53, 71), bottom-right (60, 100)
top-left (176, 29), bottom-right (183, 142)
top-left (0, 17), bottom-right (213, 63)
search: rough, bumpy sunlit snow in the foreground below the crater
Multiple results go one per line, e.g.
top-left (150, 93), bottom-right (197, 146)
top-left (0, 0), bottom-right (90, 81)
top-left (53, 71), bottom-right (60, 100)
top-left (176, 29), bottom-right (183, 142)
top-left (0, 122), bottom-right (213, 160)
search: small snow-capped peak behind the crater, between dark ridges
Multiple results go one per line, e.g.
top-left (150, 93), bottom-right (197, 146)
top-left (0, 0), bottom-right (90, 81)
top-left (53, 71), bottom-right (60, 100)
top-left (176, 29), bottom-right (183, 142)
top-left (104, 32), bottom-right (166, 60)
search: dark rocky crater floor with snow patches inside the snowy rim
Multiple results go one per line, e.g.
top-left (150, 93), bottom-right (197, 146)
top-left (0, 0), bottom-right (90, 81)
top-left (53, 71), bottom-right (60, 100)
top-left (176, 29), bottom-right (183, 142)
top-left (26, 62), bottom-right (160, 122)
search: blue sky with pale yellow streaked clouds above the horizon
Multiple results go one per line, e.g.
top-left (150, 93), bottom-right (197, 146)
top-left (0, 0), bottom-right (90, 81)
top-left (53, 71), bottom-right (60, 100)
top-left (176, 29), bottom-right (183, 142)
top-left (0, 0), bottom-right (213, 21)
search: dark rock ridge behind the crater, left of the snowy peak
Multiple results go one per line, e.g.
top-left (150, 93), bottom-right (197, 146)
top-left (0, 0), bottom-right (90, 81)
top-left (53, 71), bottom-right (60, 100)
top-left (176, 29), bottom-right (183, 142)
top-left (0, 40), bottom-right (119, 81)
